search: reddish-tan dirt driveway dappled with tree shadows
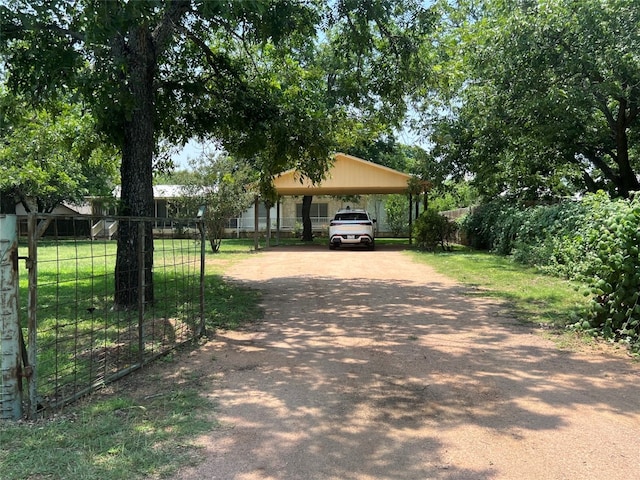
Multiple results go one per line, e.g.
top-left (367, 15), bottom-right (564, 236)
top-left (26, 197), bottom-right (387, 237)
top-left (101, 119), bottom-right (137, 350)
top-left (180, 247), bottom-right (640, 480)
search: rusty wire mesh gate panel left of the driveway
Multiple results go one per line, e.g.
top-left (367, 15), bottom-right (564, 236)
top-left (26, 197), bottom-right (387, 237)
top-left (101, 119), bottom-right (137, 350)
top-left (0, 215), bottom-right (204, 416)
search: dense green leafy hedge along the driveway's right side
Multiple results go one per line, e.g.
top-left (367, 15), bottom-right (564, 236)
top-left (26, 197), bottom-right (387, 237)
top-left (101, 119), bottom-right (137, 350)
top-left (464, 192), bottom-right (640, 349)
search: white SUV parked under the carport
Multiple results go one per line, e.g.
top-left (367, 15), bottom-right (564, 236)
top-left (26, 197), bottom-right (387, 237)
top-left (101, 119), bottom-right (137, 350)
top-left (329, 208), bottom-right (376, 250)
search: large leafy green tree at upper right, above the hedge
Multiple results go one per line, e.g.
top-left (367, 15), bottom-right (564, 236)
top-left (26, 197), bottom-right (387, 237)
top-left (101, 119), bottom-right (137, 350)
top-left (424, 0), bottom-right (640, 200)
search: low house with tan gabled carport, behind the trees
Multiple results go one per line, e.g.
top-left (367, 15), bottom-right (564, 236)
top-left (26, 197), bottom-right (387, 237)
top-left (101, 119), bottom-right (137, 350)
top-left (18, 153), bottom-right (420, 238)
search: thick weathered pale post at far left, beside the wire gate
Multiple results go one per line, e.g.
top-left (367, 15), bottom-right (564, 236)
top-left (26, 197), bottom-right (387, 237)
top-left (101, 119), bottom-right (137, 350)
top-left (0, 215), bottom-right (22, 420)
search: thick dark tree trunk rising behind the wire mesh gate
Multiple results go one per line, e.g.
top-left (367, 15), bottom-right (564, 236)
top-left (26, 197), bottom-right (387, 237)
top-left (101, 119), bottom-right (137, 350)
top-left (115, 28), bottom-right (156, 308)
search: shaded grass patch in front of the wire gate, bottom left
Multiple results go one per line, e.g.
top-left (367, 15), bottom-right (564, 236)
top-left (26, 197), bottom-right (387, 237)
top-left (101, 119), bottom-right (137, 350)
top-left (0, 373), bottom-right (216, 480)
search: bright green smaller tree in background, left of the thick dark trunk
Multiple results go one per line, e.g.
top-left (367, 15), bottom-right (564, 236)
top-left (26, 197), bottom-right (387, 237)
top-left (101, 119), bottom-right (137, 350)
top-left (0, 89), bottom-right (118, 226)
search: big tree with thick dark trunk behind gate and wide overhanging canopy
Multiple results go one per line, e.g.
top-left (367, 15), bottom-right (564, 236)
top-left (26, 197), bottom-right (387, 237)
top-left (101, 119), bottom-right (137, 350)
top-left (0, 0), bottom-right (433, 307)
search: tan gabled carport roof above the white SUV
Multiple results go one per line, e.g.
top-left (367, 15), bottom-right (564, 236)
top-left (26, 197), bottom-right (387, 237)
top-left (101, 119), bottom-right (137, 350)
top-left (273, 153), bottom-right (412, 196)
